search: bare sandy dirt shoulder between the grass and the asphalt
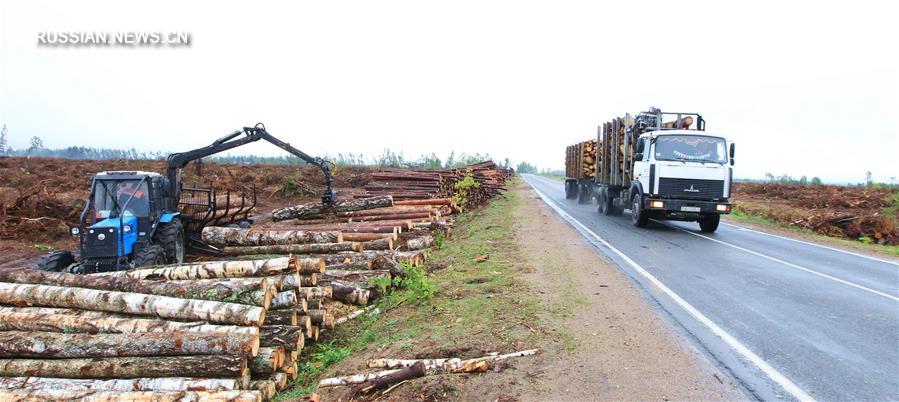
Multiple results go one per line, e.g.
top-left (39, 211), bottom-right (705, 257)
top-left (515, 183), bottom-right (745, 400)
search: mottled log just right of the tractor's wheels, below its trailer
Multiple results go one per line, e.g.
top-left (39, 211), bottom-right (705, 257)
top-left (202, 226), bottom-right (343, 246)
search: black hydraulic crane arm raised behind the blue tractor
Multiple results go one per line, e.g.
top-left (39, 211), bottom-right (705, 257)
top-left (166, 123), bottom-right (336, 207)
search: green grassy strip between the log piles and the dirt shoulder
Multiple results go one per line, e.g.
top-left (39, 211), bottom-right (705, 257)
top-left (276, 180), bottom-right (548, 399)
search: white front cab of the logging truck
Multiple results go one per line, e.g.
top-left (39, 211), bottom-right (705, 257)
top-left (630, 130), bottom-right (734, 232)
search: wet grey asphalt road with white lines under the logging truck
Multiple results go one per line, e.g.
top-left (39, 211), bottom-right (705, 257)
top-left (525, 175), bottom-right (899, 401)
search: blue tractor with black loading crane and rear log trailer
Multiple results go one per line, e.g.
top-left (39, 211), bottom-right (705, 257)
top-left (38, 123), bottom-right (335, 273)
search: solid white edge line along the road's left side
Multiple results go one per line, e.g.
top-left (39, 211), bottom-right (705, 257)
top-left (525, 179), bottom-right (815, 401)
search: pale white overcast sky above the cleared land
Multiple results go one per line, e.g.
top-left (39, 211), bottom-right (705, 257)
top-left (0, 0), bottom-right (899, 182)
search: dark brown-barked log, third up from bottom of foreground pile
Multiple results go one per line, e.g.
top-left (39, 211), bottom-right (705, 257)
top-left (0, 355), bottom-right (247, 379)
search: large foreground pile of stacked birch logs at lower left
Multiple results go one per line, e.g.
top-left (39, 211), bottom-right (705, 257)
top-left (0, 257), bottom-right (333, 400)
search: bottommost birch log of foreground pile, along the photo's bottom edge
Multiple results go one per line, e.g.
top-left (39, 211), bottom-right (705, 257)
top-left (0, 389), bottom-right (262, 402)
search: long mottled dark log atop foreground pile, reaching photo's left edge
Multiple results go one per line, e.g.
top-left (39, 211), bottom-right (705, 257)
top-left (0, 269), bottom-right (271, 306)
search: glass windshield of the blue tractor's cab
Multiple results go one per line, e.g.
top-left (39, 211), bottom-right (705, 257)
top-left (94, 180), bottom-right (150, 219)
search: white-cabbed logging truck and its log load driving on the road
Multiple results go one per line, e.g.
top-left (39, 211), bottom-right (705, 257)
top-left (565, 108), bottom-right (734, 232)
